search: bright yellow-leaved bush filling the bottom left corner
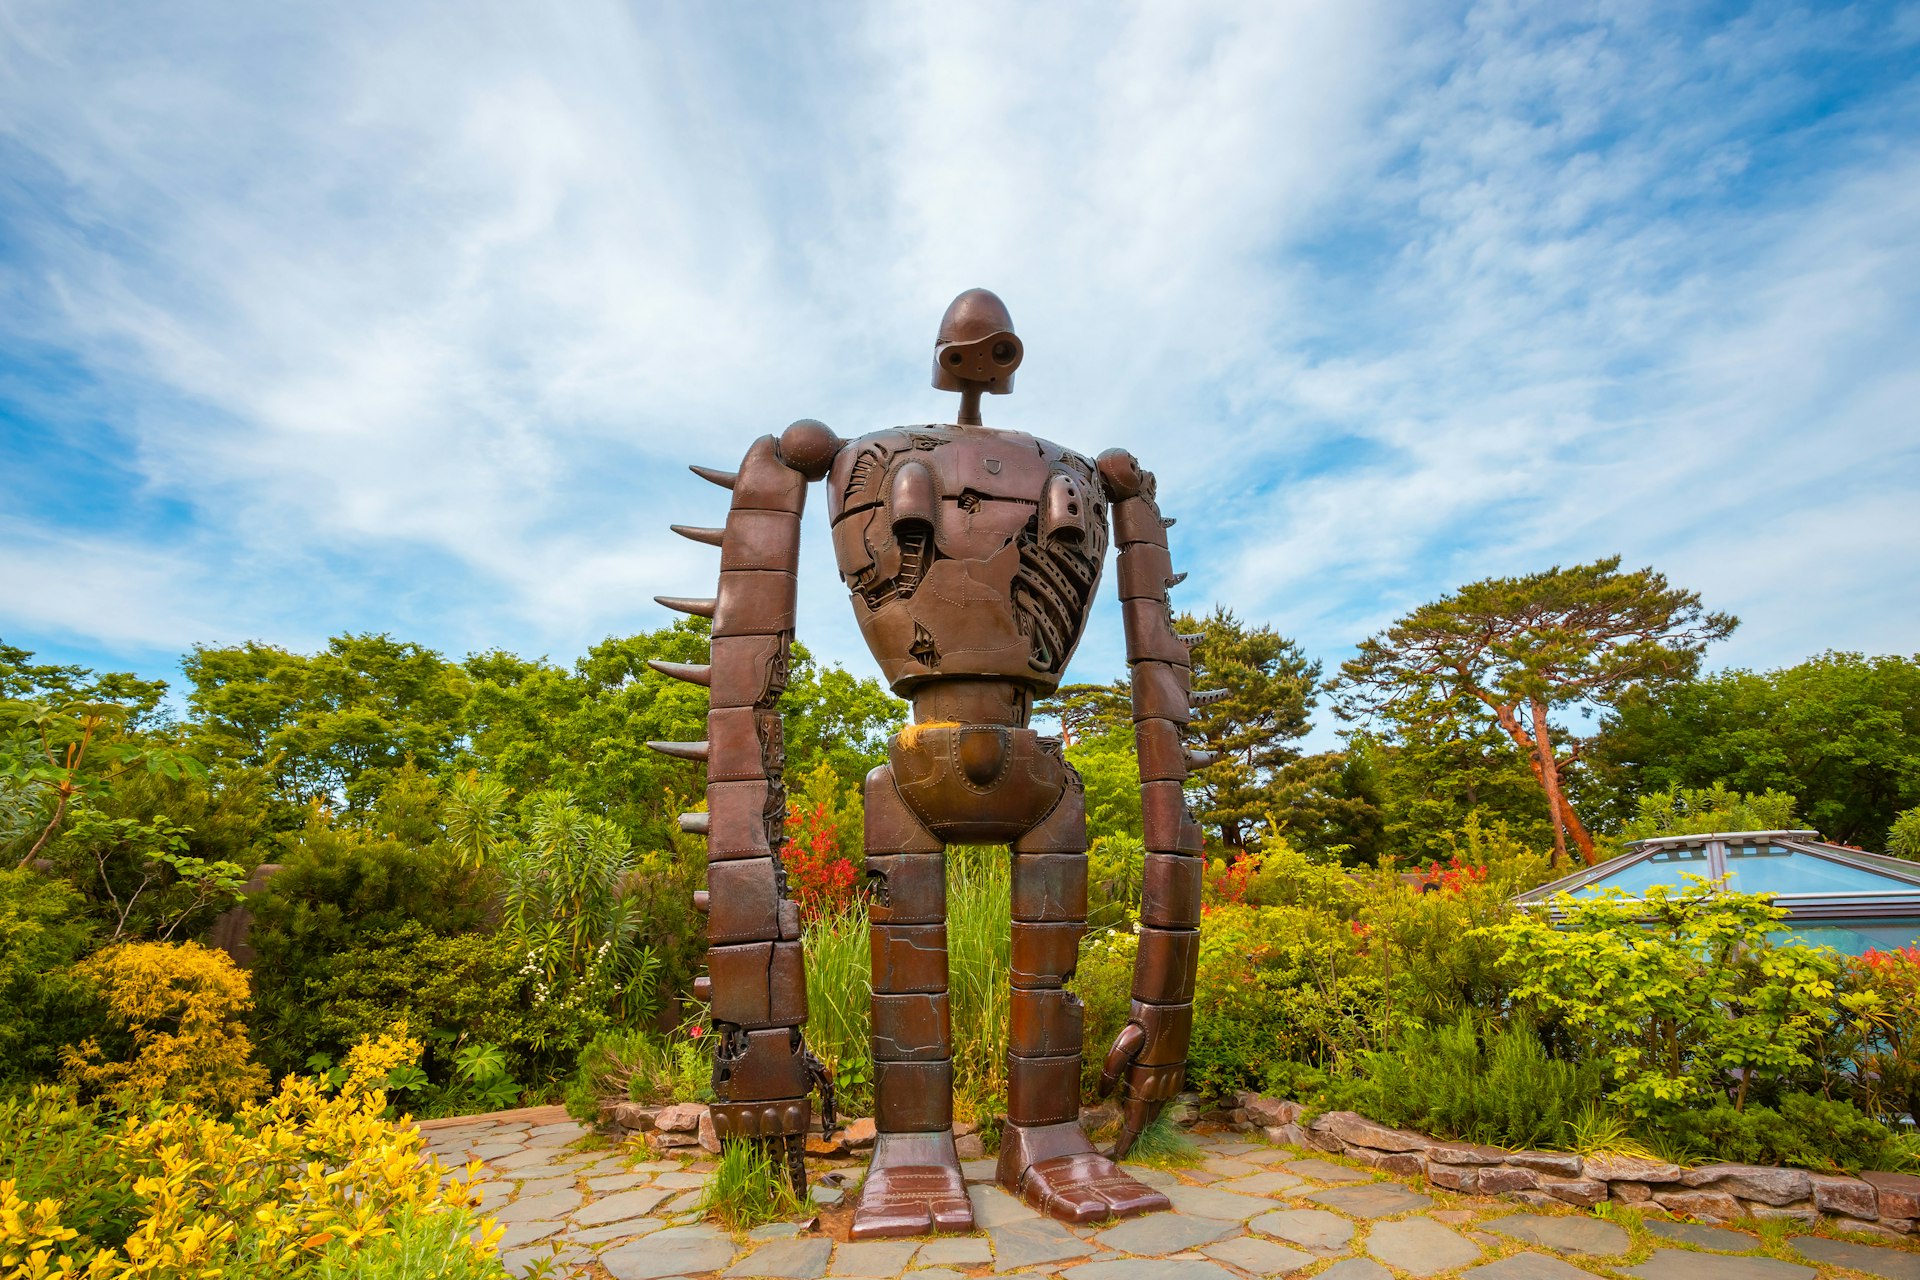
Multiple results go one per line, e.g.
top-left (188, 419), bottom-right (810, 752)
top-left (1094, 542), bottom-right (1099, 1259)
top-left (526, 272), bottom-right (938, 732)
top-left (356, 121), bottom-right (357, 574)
top-left (0, 1034), bottom-right (503, 1280)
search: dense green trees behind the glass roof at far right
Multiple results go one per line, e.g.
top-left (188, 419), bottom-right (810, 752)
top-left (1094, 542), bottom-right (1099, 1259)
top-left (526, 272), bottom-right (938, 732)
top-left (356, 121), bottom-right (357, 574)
top-left (1588, 652), bottom-right (1920, 848)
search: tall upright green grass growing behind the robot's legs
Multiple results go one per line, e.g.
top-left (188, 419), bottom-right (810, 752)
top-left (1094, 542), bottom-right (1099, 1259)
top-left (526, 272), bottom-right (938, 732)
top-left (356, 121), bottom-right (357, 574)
top-left (804, 844), bottom-right (1014, 1119)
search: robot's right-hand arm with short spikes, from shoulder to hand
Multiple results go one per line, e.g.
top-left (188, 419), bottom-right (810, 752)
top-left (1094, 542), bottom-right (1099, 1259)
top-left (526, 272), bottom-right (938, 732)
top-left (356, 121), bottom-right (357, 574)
top-left (1100, 449), bottom-right (1213, 1159)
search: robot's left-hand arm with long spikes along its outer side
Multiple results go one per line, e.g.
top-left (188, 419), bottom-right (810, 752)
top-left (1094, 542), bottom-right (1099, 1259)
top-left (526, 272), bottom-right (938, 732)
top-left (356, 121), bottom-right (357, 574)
top-left (649, 420), bottom-right (841, 1186)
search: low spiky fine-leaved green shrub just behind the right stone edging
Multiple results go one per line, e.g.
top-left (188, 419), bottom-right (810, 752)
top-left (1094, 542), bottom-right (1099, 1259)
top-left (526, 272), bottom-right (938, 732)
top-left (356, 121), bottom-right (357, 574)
top-left (1329, 1013), bottom-right (1603, 1148)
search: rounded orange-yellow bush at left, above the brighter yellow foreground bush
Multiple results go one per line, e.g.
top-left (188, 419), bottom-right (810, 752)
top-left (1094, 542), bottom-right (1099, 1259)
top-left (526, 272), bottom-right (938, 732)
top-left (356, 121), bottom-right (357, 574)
top-left (63, 942), bottom-right (267, 1111)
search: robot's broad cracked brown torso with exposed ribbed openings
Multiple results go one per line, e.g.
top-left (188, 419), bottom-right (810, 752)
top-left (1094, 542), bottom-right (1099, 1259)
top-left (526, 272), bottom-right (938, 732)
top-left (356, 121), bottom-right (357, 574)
top-left (828, 426), bottom-right (1106, 693)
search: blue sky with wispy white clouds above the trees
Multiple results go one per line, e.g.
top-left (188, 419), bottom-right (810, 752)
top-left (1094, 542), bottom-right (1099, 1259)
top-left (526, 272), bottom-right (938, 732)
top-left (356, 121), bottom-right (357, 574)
top-left (0, 0), bottom-right (1920, 737)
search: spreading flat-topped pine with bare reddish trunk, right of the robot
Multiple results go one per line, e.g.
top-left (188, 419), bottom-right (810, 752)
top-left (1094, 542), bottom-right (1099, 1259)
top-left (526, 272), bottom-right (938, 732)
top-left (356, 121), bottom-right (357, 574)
top-left (1340, 557), bottom-right (1738, 864)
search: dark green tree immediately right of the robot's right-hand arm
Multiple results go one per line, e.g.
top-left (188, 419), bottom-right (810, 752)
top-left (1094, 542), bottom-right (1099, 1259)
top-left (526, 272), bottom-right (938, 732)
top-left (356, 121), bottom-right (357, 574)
top-left (1175, 606), bottom-right (1321, 850)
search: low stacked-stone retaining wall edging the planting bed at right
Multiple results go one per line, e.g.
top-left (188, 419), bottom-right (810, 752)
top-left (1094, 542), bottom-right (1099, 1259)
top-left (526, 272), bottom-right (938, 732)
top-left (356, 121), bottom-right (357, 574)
top-left (1233, 1094), bottom-right (1920, 1236)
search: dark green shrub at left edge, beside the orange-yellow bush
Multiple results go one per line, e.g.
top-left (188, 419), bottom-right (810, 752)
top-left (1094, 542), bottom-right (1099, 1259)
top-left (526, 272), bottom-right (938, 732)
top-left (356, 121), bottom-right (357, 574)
top-left (0, 869), bottom-right (102, 1086)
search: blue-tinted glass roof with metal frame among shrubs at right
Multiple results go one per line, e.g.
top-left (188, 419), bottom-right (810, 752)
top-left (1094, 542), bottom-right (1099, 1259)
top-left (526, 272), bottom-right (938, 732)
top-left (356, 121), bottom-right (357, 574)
top-left (1515, 831), bottom-right (1920, 954)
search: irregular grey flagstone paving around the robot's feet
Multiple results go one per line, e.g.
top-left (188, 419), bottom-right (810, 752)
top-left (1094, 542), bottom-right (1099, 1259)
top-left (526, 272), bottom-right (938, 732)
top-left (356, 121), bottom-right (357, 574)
top-left (420, 1107), bottom-right (1920, 1280)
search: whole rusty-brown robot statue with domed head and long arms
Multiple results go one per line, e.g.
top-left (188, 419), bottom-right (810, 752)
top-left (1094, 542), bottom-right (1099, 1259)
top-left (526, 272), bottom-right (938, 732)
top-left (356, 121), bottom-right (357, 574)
top-left (653, 290), bottom-right (1210, 1240)
